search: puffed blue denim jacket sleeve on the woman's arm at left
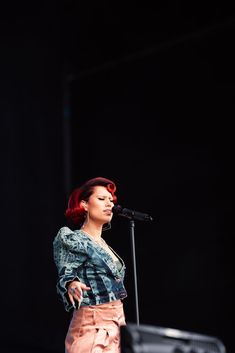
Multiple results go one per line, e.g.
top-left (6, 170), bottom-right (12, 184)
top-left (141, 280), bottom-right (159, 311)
top-left (53, 227), bottom-right (87, 311)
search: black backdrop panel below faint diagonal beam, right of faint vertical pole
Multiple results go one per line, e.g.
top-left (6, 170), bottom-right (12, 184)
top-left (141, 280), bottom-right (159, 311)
top-left (68, 37), bottom-right (235, 352)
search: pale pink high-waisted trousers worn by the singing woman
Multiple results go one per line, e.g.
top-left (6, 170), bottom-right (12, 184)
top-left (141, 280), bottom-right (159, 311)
top-left (65, 300), bottom-right (126, 353)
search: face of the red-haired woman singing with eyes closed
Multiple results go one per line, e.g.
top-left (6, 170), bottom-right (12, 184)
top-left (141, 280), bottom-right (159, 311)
top-left (86, 186), bottom-right (114, 224)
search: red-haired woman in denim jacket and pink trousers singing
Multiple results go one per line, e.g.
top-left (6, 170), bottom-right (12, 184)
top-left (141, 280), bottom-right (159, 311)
top-left (53, 177), bottom-right (127, 353)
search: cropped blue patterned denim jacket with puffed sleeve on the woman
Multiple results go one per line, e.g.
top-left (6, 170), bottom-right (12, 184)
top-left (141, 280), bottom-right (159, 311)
top-left (53, 227), bottom-right (127, 311)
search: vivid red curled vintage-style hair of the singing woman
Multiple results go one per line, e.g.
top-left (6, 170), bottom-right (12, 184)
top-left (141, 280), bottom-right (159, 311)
top-left (65, 177), bottom-right (117, 225)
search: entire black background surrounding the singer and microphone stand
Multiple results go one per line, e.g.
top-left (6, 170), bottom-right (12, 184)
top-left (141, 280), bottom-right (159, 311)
top-left (0, 1), bottom-right (235, 353)
